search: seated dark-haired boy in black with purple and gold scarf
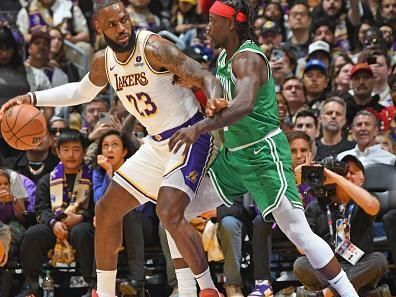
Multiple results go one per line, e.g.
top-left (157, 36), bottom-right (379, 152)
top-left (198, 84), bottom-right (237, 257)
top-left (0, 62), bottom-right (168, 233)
top-left (17, 130), bottom-right (94, 297)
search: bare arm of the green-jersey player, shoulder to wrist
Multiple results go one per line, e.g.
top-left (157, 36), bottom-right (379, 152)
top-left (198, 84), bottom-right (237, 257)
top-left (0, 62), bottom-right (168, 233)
top-left (196, 52), bottom-right (268, 134)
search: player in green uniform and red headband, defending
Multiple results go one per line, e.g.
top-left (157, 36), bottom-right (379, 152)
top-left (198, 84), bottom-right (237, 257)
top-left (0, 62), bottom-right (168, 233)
top-left (169, 0), bottom-right (358, 297)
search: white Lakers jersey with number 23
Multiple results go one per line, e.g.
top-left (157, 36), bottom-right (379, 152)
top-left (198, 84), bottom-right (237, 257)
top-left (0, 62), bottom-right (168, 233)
top-left (105, 31), bottom-right (198, 135)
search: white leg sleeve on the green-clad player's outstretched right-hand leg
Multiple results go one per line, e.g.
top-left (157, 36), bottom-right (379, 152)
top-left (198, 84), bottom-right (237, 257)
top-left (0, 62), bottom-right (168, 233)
top-left (272, 197), bottom-right (334, 269)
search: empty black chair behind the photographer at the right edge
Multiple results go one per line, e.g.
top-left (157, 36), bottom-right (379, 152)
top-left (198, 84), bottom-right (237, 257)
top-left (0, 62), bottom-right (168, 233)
top-left (363, 164), bottom-right (396, 251)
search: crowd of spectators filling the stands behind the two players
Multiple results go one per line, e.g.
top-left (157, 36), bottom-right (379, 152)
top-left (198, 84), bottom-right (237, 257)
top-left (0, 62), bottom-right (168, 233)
top-left (0, 0), bottom-right (396, 297)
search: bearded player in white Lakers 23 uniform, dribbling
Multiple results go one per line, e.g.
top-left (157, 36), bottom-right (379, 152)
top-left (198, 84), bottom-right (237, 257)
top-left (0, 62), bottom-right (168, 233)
top-left (0, 0), bottom-right (227, 297)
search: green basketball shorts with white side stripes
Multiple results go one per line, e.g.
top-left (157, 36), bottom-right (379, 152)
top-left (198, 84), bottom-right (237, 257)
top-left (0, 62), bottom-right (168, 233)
top-left (209, 132), bottom-right (303, 220)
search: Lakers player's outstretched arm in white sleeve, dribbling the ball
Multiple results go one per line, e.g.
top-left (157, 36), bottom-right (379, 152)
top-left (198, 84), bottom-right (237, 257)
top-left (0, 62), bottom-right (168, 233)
top-left (0, 52), bottom-right (108, 121)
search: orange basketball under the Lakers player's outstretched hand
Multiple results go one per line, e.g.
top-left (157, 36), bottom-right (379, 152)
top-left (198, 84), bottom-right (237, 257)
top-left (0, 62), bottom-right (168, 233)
top-left (1, 104), bottom-right (47, 150)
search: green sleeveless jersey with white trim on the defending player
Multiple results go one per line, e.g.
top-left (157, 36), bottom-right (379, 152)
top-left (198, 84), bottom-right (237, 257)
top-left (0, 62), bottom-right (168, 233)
top-left (216, 40), bottom-right (280, 149)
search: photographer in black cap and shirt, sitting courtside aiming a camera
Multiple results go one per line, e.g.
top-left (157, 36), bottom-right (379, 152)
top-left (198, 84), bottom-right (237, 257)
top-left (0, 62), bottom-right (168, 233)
top-left (294, 155), bottom-right (387, 297)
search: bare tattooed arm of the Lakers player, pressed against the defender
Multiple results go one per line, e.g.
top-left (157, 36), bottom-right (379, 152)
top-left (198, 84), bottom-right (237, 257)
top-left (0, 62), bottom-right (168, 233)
top-left (145, 35), bottom-right (222, 98)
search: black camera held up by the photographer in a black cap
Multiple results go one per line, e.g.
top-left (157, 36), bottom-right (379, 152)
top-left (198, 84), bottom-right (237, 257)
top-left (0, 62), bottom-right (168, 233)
top-left (301, 156), bottom-right (348, 199)
